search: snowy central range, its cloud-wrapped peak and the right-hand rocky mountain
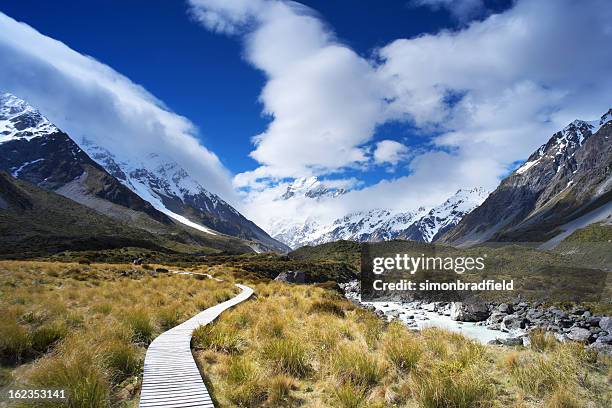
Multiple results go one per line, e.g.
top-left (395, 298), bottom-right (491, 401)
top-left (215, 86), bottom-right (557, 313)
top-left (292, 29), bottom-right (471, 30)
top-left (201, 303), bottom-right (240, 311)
top-left (270, 109), bottom-right (612, 249)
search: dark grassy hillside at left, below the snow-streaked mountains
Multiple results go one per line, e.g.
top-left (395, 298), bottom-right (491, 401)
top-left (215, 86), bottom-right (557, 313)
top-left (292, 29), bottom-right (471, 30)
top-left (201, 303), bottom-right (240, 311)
top-left (0, 173), bottom-right (260, 259)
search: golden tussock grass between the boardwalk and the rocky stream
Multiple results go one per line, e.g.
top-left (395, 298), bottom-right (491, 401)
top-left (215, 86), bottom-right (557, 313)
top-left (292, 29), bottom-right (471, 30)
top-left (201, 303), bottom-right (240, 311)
top-left (194, 282), bottom-right (612, 408)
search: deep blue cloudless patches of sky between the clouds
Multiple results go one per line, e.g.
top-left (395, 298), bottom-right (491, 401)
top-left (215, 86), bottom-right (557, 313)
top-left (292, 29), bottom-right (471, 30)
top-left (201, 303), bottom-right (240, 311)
top-left (0, 0), bottom-right (509, 183)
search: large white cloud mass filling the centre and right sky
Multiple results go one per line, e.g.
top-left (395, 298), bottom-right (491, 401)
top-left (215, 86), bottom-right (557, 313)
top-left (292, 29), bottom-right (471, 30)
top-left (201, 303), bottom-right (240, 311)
top-left (191, 0), bottom-right (612, 231)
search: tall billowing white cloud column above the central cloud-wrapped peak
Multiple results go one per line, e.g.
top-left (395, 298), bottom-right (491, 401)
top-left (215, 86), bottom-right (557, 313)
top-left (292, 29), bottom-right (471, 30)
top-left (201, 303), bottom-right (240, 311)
top-left (191, 0), bottom-right (384, 186)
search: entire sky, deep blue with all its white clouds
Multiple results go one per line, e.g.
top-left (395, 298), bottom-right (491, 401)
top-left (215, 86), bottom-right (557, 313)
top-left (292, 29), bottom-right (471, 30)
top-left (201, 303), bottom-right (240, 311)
top-left (0, 0), bottom-right (612, 227)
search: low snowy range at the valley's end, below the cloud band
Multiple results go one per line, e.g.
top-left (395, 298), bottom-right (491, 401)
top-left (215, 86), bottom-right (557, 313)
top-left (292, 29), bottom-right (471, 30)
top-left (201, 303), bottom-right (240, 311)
top-left (271, 188), bottom-right (487, 248)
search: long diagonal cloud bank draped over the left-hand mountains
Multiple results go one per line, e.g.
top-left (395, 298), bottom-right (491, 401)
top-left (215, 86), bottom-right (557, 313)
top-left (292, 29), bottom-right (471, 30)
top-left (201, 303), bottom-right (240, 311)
top-left (0, 13), bottom-right (238, 202)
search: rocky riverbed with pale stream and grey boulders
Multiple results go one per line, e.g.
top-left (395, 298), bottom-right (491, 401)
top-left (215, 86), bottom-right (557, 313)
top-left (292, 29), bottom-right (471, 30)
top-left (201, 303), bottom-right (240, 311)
top-left (342, 281), bottom-right (612, 355)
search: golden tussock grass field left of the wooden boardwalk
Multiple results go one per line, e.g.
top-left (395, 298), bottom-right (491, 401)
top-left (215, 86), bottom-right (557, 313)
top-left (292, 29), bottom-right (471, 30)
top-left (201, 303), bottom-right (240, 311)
top-left (0, 261), bottom-right (237, 408)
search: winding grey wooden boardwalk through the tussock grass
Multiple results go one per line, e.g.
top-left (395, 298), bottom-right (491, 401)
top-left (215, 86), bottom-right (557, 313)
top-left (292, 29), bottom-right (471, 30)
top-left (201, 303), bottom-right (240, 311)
top-left (139, 284), bottom-right (253, 408)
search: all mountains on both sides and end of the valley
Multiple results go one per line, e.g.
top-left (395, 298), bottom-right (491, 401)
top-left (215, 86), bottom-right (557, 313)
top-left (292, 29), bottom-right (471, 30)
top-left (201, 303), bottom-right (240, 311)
top-left (0, 94), bottom-right (612, 253)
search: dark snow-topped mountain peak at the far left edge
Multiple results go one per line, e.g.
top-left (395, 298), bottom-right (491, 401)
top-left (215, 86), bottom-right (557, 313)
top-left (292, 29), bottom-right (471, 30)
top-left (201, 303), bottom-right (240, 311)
top-left (0, 94), bottom-right (170, 224)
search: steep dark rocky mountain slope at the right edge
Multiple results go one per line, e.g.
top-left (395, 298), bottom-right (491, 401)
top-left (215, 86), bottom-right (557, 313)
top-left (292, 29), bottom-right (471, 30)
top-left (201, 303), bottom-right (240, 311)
top-left (441, 109), bottom-right (612, 246)
